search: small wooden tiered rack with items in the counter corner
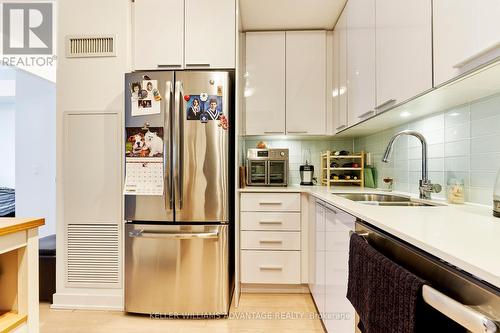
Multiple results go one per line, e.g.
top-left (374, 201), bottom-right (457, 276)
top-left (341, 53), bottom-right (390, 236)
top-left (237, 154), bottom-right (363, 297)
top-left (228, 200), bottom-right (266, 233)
top-left (321, 150), bottom-right (365, 187)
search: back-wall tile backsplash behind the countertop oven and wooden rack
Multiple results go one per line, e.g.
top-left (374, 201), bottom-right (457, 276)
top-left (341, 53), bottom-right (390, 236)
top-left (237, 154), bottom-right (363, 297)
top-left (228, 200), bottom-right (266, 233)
top-left (245, 138), bottom-right (353, 185)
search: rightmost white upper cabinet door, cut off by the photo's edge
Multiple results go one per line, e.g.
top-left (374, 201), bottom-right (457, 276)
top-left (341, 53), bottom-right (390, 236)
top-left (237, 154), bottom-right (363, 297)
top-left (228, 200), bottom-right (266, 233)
top-left (433, 0), bottom-right (500, 86)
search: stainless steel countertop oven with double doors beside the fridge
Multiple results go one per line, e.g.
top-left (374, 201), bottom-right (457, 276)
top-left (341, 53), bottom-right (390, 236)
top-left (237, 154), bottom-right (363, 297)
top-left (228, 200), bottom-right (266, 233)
top-left (246, 148), bottom-right (288, 186)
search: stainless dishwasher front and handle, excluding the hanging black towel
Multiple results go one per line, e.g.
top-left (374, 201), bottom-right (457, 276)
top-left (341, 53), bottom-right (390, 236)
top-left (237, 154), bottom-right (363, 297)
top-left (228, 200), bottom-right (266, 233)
top-left (355, 220), bottom-right (500, 333)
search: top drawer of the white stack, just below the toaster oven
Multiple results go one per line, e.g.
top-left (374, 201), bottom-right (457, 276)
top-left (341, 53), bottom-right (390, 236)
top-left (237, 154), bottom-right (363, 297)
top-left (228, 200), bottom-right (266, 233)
top-left (241, 193), bottom-right (300, 212)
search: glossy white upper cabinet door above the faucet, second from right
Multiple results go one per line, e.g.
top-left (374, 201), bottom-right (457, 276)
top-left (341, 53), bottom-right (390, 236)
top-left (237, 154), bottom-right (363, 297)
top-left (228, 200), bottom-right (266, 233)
top-left (376, 0), bottom-right (439, 112)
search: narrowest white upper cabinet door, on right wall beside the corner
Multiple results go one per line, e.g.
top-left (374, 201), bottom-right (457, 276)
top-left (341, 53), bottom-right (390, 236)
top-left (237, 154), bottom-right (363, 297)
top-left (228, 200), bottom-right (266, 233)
top-left (332, 12), bottom-right (348, 133)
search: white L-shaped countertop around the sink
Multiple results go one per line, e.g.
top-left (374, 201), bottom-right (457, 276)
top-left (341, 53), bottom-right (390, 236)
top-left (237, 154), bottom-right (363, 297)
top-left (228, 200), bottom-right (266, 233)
top-left (240, 186), bottom-right (500, 288)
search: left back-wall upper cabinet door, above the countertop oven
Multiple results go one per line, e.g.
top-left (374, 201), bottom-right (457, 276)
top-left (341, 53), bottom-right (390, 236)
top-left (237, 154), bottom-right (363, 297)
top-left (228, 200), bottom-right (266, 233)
top-left (244, 32), bottom-right (285, 135)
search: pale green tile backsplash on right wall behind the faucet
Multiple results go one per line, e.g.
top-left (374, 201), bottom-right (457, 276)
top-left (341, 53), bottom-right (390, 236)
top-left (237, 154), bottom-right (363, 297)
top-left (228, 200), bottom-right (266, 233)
top-left (354, 91), bottom-right (500, 205)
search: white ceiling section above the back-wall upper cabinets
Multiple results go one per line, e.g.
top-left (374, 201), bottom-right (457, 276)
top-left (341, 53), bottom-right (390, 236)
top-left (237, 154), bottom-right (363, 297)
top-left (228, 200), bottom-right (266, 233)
top-left (240, 0), bottom-right (347, 31)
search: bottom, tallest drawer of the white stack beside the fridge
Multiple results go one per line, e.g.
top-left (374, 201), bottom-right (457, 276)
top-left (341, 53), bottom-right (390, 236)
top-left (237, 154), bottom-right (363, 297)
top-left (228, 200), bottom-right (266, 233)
top-left (241, 250), bottom-right (300, 284)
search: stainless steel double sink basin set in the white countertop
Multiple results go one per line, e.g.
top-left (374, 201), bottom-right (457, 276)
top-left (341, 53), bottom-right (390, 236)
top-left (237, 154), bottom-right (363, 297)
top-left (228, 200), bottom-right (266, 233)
top-left (333, 193), bottom-right (438, 207)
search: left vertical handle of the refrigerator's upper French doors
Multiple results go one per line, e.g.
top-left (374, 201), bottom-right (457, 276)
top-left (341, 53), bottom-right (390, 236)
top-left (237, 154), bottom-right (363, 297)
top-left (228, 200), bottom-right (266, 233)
top-left (163, 81), bottom-right (174, 209)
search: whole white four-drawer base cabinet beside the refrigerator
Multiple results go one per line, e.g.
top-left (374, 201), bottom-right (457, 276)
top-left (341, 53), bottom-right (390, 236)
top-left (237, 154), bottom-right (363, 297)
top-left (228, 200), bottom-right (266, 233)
top-left (240, 192), bottom-right (302, 285)
